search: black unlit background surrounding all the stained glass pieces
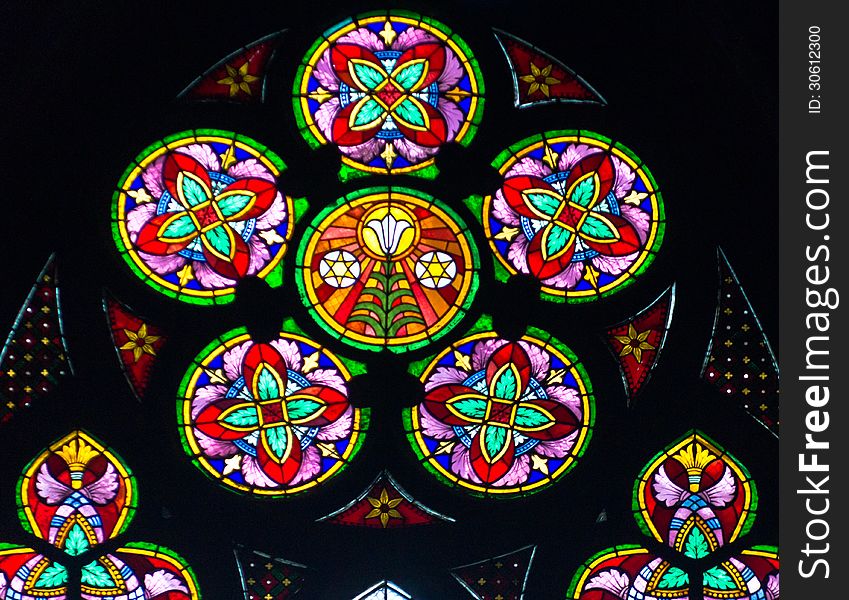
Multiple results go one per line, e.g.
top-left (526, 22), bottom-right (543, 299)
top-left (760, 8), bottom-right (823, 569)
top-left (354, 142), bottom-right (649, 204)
top-left (0, 0), bottom-right (778, 600)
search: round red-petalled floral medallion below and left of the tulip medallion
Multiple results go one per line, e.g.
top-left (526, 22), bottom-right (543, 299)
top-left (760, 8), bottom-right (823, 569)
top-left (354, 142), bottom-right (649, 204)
top-left (177, 324), bottom-right (368, 496)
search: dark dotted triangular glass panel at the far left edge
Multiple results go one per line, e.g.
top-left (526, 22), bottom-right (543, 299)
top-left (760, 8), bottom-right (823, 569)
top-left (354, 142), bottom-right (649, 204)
top-left (0, 254), bottom-right (72, 423)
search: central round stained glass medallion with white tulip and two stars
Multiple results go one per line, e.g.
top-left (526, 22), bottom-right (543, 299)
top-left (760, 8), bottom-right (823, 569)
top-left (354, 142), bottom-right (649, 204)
top-left (297, 187), bottom-right (479, 352)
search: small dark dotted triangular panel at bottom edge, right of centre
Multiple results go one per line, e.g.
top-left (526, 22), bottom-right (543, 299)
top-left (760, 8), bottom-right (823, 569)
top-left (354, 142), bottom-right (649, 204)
top-left (451, 546), bottom-right (536, 600)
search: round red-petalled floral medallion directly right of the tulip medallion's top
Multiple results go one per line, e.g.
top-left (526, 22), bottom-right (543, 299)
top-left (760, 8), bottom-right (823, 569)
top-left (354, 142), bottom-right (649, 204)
top-left (476, 131), bottom-right (665, 302)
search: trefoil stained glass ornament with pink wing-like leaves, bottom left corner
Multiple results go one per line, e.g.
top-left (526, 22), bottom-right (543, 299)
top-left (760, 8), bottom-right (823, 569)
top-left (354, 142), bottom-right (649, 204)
top-left (0, 431), bottom-right (200, 600)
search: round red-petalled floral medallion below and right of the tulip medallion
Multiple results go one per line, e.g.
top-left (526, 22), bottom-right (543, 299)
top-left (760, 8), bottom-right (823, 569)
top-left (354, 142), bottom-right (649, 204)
top-left (404, 330), bottom-right (595, 497)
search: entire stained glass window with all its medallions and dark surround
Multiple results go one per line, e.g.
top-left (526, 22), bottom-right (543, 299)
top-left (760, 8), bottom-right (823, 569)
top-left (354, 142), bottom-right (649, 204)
top-left (0, 0), bottom-right (786, 600)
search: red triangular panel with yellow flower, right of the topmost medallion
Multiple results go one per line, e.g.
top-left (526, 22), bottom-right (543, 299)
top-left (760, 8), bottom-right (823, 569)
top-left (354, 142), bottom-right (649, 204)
top-left (494, 29), bottom-right (607, 108)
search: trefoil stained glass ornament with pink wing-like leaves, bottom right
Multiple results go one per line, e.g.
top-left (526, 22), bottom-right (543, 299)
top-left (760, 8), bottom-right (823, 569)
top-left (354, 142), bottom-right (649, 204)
top-left (568, 431), bottom-right (779, 600)
